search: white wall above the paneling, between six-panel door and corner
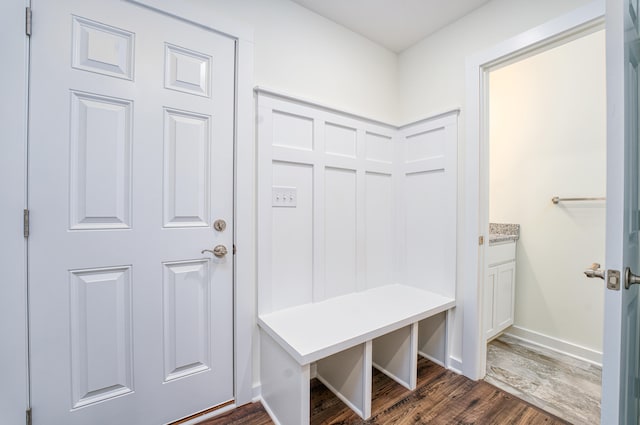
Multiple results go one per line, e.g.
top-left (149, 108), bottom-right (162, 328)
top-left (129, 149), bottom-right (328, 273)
top-left (189, 0), bottom-right (399, 124)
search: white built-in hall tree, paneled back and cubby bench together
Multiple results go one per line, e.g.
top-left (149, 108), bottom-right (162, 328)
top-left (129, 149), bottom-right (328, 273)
top-left (258, 90), bottom-right (457, 424)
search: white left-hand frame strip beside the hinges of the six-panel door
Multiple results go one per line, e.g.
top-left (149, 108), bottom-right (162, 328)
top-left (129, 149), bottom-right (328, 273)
top-left (0, 0), bottom-right (29, 423)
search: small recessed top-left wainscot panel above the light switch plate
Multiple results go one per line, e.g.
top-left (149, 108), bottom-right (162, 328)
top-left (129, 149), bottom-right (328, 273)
top-left (273, 111), bottom-right (314, 151)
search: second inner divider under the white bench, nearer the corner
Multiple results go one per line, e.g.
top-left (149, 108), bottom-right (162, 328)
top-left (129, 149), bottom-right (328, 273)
top-left (373, 323), bottom-right (418, 390)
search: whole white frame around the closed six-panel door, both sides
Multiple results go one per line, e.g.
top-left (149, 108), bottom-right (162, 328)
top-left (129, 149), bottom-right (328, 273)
top-left (0, 0), bottom-right (256, 423)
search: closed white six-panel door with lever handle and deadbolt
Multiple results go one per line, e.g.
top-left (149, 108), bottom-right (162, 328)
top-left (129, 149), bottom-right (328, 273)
top-left (29, 0), bottom-right (235, 425)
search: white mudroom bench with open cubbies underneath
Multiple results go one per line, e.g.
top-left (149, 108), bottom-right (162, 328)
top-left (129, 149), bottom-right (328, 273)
top-left (258, 285), bottom-right (455, 425)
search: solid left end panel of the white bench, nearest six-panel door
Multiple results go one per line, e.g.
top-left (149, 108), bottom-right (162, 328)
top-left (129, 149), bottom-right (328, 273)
top-left (260, 330), bottom-right (310, 425)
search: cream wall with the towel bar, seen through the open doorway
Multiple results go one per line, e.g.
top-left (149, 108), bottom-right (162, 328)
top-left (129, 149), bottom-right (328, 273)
top-left (489, 30), bottom-right (606, 352)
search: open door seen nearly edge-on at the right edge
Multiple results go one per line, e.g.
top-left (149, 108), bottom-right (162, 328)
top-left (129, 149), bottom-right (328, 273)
top-left (601, 0), bottom-right (640, 425)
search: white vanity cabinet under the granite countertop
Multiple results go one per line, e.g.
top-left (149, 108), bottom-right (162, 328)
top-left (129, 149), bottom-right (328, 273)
top-left (484, 241), bottom-right (516, 340)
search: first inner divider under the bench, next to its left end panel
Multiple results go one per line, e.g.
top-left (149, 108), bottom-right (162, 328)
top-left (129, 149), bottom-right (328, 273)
top-left (317, 341), bottom-right (372, 419)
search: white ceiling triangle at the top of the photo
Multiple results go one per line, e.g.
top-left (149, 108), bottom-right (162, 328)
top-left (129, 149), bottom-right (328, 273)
top-left (293, 0), bottom-right (489, 53)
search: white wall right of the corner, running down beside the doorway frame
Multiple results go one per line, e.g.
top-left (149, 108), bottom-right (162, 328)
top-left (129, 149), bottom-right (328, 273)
top-left (398, 0), bottom-right (591, 368)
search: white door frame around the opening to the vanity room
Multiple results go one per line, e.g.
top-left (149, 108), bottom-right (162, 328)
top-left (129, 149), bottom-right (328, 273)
top-left (460, 0), bottom-right (605, 380)
